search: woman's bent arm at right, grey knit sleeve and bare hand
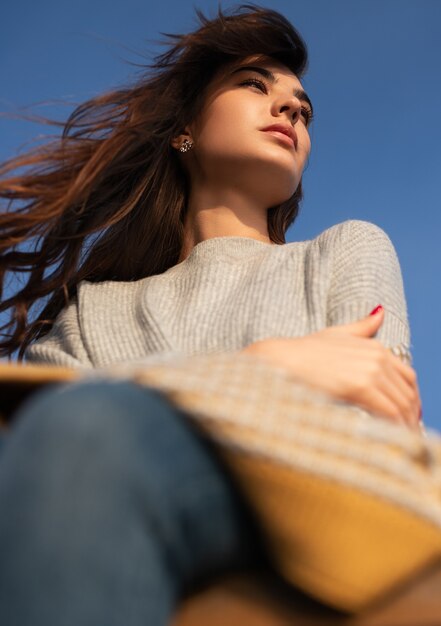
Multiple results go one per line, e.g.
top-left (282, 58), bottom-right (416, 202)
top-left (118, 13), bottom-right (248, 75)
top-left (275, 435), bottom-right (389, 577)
top-left (244, 221), bottom-right (421, 429)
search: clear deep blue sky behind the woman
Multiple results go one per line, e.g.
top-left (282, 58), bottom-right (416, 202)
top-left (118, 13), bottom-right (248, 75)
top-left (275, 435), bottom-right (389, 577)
top-left (0, 0), bottom-right (441, 430)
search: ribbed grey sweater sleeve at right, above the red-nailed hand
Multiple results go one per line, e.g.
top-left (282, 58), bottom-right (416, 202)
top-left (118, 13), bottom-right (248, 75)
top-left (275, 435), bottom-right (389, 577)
top-left (326, 220), bottom-right (412, 364)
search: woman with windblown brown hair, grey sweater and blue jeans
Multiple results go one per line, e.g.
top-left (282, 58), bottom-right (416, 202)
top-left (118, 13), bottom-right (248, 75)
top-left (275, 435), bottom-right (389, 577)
top-left (0, 5), bottom-right (421, 626)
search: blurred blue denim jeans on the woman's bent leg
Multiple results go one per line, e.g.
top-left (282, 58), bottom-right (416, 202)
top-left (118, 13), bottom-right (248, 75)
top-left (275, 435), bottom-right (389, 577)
top-left (0, 381), bottom-right (266, 626)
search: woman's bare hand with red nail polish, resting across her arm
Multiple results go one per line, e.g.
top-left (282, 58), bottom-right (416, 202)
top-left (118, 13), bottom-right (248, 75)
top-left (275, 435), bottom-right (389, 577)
top-left (242, 309), bottom-right (421, 430)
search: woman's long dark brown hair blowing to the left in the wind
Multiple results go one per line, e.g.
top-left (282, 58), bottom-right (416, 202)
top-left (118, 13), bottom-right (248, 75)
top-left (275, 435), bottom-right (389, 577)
top-left (0, 4), bottom-right (307, 360)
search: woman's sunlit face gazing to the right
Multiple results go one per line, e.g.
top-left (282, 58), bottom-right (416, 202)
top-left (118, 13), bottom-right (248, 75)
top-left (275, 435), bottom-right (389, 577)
top-left (184, 57), bottom-right (312, 207)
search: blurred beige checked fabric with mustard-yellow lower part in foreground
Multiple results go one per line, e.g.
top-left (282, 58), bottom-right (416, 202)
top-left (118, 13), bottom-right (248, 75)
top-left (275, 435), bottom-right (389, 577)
top-left (0, 354), bottom-right (441, 611)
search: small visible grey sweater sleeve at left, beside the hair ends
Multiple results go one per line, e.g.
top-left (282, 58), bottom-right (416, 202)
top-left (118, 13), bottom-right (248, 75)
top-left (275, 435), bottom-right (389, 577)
top-left (25, 298), bottom-right (93, 368)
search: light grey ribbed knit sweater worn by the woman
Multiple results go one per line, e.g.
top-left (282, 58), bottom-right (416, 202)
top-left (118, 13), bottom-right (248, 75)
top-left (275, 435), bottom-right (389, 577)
top-left (25, 220), bottom-right (411, 368)
